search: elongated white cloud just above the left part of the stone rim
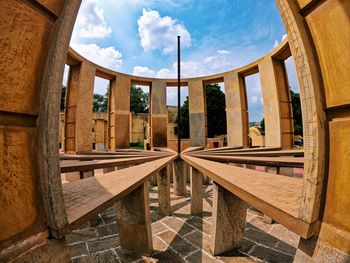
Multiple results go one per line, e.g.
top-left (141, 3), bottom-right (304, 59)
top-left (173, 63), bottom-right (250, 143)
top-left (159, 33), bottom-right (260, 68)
top-left (72, 43), bottom-right (123, 69)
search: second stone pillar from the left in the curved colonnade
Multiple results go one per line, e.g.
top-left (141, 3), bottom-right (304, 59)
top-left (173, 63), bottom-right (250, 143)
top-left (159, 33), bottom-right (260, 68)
top-left (108, 74), bottom-right (131, 150)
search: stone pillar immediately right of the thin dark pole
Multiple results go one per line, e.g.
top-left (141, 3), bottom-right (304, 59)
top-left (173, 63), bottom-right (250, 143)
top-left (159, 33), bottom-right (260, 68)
top-left (188, 80), bottom-right (206, 147)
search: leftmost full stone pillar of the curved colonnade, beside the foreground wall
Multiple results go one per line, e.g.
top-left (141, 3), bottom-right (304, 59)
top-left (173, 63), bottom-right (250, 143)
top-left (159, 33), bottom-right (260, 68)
top-left (64, 62), bottom-right (96, 153)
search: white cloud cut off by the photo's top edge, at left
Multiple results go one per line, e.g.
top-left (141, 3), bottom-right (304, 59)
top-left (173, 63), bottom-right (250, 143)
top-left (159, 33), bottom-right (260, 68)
top-left (72, 0), bottom-right (112, 42)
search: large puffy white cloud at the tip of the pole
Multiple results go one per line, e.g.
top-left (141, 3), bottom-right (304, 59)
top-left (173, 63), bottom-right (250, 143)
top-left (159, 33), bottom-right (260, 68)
top-left (137, 9), bottom-right (192, 53)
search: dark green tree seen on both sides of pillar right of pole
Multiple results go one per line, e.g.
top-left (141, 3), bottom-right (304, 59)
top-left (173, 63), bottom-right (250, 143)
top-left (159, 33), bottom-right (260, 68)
top-left (181, 84), bottom-right (227, 138)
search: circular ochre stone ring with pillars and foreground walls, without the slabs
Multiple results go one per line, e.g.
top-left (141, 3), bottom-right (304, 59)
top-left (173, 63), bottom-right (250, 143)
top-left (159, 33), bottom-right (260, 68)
top-left (0, 0), bottom-right (350, 262)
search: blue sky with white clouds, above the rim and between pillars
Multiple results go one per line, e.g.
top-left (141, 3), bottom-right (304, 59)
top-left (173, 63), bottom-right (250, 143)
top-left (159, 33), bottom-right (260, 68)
top-left (64, 0), bottom-right (297, 121)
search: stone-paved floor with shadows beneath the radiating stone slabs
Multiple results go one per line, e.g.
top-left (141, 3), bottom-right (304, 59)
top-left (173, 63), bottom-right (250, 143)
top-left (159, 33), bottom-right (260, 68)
top-left (67, 186), bottom-right (299, 263)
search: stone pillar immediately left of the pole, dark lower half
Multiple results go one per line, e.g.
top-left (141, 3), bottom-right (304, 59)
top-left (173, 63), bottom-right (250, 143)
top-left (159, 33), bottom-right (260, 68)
top-left (151, 80), bottom-right (168, 147)
